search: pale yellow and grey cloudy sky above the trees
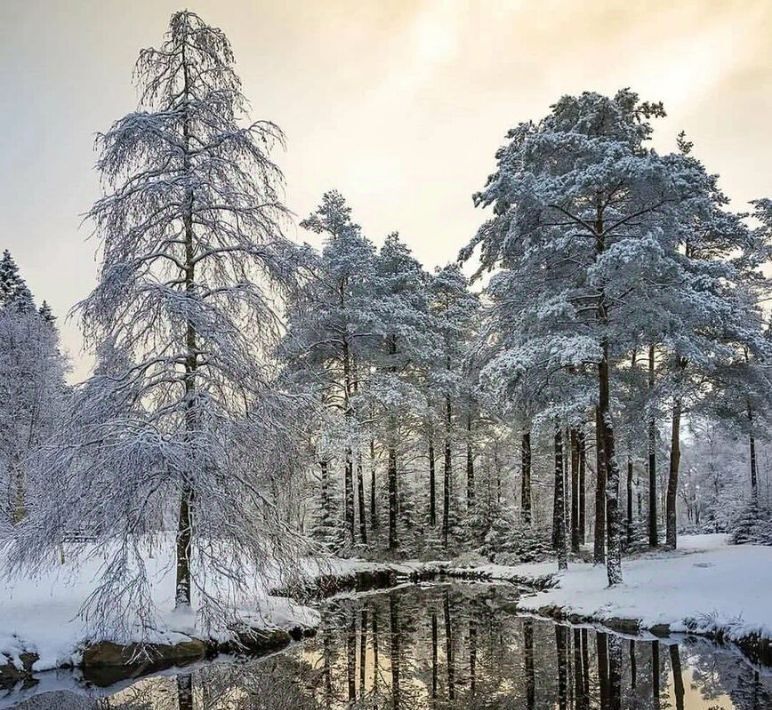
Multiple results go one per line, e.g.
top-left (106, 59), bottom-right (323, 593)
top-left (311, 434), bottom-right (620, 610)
top-left (0, 0), bottom-right (772, 379)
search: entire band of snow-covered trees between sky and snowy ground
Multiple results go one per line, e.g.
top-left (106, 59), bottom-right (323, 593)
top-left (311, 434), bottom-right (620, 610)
top-left (0, 11), bottom-right (772, 636)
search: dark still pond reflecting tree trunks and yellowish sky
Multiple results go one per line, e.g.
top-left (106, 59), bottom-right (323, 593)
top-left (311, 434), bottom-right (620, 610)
top-left (0, 583), bottom-right (772, 710)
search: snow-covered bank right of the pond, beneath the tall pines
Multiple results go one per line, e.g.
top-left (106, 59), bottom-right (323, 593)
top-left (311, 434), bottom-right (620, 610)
top-left (452, 535), bottom-right (772, 639)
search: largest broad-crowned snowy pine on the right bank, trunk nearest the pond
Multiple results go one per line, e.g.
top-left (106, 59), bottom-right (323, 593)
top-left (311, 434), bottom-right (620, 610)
top-left (462, 90), bottom-right (736, 585)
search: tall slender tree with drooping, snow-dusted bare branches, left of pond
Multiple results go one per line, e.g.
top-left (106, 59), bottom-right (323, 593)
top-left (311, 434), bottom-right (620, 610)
top-left (4, 10), bottom-right (310, 631)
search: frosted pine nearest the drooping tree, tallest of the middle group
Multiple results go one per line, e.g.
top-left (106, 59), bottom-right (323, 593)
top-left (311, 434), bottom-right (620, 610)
top-left (281, 190), bottom-right (380, 545)
